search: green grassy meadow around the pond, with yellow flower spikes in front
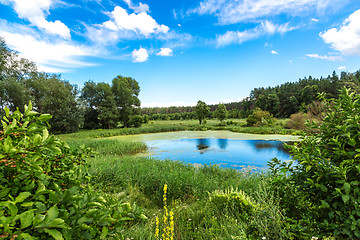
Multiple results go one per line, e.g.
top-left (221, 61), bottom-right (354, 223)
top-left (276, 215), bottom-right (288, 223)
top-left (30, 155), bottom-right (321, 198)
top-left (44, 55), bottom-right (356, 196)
top-left (59, 120), bottom-right (296, 239)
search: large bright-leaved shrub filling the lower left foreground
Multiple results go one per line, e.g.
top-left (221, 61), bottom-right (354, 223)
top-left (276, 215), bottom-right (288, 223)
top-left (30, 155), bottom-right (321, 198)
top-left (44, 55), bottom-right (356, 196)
top-left (0, 103), bottom-right (146, 240)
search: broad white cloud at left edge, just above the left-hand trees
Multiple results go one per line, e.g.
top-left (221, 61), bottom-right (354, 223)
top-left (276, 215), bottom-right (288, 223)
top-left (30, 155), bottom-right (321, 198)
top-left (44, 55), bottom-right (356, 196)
top-left (0, 21), bottom-right (98, 72)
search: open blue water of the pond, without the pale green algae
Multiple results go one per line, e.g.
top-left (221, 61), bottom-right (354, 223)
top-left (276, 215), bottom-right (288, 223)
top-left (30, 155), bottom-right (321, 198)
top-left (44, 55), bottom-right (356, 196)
top-left (146, 138), bottom-right (290, 169)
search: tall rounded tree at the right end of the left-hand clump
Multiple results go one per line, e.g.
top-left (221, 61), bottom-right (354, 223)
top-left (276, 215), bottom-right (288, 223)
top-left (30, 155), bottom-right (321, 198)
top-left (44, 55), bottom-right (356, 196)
top-left (111, 75), bottom-right (140, 127)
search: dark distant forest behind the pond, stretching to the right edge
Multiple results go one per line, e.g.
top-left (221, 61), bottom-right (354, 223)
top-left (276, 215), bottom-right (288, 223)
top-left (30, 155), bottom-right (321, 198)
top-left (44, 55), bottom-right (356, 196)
top-left (141, 70), bottom-right (360, 120)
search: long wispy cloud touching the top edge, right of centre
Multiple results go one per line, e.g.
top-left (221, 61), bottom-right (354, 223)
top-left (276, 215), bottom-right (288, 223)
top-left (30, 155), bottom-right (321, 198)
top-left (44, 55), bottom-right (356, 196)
top-left (188, 0), bottom-right (345, 24)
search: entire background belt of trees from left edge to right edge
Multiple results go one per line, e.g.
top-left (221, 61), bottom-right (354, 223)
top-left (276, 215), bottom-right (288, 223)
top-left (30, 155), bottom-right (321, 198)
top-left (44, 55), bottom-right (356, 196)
top-left (0, 38), bottom-right (360, 133)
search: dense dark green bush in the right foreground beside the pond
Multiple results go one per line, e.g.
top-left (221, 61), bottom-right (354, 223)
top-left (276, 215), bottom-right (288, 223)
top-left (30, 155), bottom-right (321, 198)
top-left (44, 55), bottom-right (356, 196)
top-left (271, 89), bottom-right (360, 239)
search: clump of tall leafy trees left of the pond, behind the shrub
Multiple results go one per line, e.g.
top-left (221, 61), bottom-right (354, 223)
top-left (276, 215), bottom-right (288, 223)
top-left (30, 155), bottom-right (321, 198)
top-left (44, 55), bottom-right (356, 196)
top-left (0, 38), bottom-right (142, 133)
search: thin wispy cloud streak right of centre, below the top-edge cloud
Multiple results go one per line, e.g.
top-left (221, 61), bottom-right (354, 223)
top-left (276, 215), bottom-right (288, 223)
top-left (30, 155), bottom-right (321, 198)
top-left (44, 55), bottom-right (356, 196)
top-left (216, 21), bottom-right (295, 47)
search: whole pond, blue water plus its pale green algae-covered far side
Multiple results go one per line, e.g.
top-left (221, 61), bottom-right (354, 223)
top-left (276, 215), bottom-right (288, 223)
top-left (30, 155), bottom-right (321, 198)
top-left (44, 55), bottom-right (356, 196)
top-left (112, 131), bottom-right (298, 169)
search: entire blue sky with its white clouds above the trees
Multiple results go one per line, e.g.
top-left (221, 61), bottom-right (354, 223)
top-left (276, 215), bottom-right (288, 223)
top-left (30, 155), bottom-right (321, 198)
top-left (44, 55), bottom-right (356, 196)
top-left (0, 0), bottom-right (360, 107)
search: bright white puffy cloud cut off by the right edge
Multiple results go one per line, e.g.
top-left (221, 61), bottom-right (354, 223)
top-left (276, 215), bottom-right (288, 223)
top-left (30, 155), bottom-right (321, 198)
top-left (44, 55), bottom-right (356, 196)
top-left (319, 9), bottom-right (360, 55)
